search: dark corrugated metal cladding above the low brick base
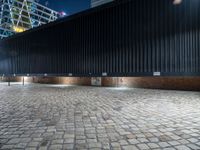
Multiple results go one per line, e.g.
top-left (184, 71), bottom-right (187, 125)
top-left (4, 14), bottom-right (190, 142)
top-left (0, 0), bottom-right (200, 76)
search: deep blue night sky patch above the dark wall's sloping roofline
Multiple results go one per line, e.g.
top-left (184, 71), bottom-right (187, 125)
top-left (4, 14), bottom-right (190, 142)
top-left (39, 0), bottom-right (90, 15)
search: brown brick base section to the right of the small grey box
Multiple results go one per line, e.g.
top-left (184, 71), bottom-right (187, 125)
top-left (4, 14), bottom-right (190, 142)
top-left (102, 77), bottom-right (200, 91)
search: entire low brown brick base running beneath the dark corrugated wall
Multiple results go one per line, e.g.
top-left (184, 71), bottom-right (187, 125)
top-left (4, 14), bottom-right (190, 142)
top-left (2, 77), bottom-right (200, 91)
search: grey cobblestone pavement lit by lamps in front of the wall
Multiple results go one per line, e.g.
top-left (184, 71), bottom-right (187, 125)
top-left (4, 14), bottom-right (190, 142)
top-left (0, 84), bottom-right (200, 150)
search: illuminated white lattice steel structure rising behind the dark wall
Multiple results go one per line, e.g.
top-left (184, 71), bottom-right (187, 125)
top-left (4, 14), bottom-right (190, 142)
top-left (0, 0), bottom-right (59, 39)
